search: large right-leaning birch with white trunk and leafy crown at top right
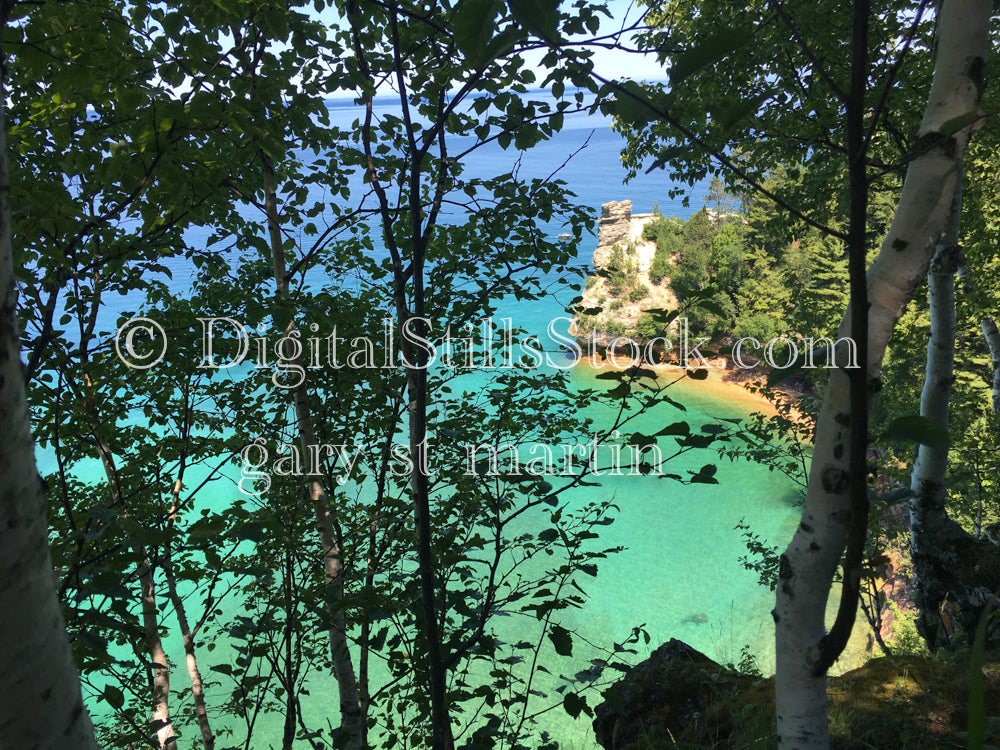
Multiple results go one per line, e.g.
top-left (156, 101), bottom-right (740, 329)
top-left (618, 0), bottom-right (990, 747)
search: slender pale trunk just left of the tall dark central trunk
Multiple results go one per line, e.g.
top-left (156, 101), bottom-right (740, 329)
top-left (261, 154), bottom-right (368, 750)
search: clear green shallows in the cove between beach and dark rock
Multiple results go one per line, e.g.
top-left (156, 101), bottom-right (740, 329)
top-left (504, 368), bottom-right (799, 748)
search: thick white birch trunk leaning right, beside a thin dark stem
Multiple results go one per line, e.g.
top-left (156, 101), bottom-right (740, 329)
top-left (774, 0), bottom-right (991, 748)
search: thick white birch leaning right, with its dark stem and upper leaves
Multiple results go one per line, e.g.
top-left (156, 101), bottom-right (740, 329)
top-left (613, 0), bottom-right (990, 748)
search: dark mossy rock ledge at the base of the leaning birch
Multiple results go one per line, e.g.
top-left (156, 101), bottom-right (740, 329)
top-left (594, 640), bottom-right (1000, 750)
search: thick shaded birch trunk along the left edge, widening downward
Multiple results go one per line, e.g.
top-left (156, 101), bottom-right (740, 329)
top-left (0, 58), bottom-right (97, 750)
